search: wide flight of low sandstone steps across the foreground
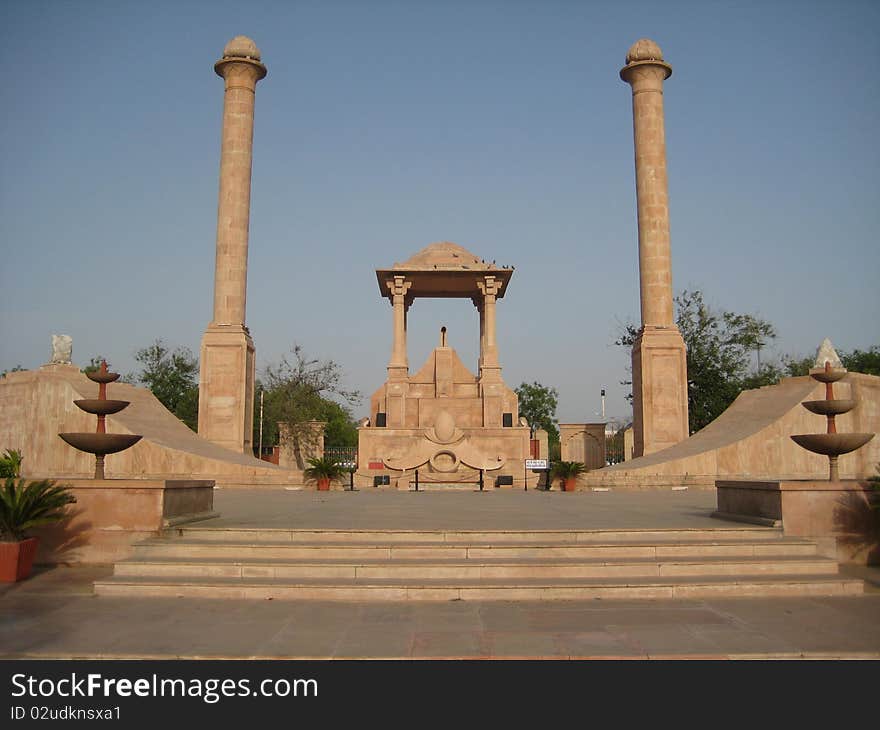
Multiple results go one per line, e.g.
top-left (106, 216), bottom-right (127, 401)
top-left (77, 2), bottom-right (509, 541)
top-left (95, 527), bottom-right (864, 601)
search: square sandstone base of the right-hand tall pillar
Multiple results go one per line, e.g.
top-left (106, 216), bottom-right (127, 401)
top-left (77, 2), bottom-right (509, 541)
top-left (632, 326), bottom-right (689, 457)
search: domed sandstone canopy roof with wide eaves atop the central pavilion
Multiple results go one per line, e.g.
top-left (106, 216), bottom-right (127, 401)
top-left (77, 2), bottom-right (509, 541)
top-left (376, 241), bottom-right (514, 300)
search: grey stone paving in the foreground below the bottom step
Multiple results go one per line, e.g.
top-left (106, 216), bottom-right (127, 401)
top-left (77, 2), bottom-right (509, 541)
top-left (0, 566), bottom-right (880, 659)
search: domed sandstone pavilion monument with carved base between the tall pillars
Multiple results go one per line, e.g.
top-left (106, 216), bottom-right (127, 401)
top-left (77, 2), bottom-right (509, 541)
top-left (358, 241), bottom-right (530, 488)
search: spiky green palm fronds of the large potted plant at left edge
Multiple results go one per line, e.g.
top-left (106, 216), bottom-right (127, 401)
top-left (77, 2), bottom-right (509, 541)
top-left (0, 477), bottom-right (76, 542)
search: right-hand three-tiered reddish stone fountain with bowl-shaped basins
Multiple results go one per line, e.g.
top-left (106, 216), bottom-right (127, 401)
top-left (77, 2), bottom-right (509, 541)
top-left (791, 339), bottom-right (874, 482)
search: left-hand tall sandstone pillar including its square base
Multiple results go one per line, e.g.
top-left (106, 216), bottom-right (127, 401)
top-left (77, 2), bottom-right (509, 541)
top-left (199, 36), bottom-right (266, 454)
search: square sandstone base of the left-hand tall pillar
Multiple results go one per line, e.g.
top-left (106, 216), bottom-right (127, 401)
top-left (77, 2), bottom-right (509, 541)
top-left (199, 324), bottom-right (256, 454)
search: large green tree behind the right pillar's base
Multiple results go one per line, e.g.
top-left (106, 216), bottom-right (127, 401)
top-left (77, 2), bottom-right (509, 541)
top-left (615, 290), bottom-right (783, 433)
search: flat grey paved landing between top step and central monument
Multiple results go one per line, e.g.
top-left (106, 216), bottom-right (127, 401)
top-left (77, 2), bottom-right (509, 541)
top-left (208, 487), bottom-right (728, 530)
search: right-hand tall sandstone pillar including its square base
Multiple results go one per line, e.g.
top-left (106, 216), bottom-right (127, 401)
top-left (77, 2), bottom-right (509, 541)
top-left (620, 39), bottom-right (688, 456)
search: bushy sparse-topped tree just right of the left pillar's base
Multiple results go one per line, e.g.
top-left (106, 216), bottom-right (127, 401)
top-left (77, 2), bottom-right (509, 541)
top-left (254, 344), bottom-right (361, 456)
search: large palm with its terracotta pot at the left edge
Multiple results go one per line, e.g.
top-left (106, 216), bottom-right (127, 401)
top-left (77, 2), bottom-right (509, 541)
top-left (0, 477), bottom-right (76, 583)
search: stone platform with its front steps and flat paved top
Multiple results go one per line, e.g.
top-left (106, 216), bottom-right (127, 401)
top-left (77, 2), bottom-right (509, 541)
top-left (95, 490), bottom-right (863, 601)
